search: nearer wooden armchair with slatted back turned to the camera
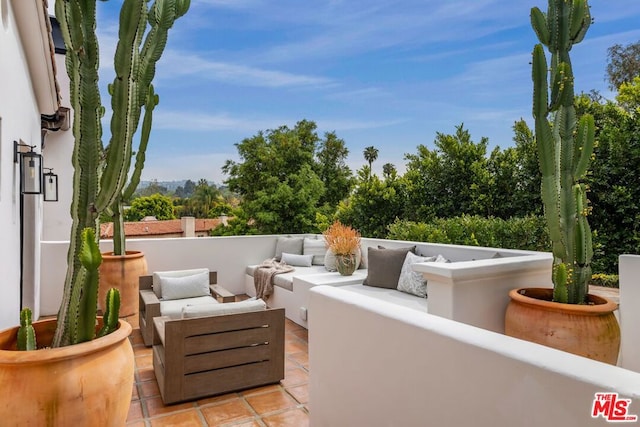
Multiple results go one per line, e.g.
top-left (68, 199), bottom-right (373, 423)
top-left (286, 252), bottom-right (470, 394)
top-left (153, 301), bottom-right (285, 404)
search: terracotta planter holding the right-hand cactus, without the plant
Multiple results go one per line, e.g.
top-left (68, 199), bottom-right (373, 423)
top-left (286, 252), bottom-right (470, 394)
top-left (505, 288), bottom-right (620, 365)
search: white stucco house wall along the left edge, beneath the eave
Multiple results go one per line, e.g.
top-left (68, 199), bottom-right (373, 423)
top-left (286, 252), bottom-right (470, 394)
top-left (0, 1), bottom-right (42, 328)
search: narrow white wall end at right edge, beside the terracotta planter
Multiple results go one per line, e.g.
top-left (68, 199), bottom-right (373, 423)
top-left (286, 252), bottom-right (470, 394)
top-left (618, 255), bottom-right (640, 372)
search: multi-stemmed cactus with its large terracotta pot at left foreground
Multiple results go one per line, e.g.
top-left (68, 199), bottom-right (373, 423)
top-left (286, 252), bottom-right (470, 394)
top-left (0, 0), bottom-right (190, 426)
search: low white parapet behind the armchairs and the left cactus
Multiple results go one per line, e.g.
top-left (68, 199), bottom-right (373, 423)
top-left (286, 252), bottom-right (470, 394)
top-left (40, 236), bottom-right (276, 316)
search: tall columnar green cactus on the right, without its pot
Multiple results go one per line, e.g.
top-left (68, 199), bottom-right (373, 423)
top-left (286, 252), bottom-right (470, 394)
top-left (531, 0), bottom-right (595, 304)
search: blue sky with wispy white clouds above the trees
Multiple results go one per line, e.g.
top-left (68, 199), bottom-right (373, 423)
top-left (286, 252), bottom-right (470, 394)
top-left (91, 0), bottom-right (640, 183)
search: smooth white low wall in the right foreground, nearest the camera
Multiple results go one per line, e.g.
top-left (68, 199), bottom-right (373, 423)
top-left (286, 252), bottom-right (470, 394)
top-left (309, 286), bottom-right (640, 427)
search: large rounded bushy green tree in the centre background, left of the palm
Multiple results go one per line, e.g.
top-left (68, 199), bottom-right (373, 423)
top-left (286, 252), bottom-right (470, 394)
top-left (222, 120), bottom-right (325, 233)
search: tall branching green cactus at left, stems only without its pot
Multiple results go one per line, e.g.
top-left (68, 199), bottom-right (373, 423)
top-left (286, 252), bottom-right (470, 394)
top-left (52, 0), bottom-right (190, 347)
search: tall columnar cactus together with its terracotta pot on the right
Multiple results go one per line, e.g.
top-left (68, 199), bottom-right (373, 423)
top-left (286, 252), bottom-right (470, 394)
top-left (505, 0), bottom-right (620, 364)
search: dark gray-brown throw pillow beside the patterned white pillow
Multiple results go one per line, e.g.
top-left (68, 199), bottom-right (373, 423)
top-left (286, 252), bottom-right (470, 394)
top-left (363, 246), bottom-right (415, 289)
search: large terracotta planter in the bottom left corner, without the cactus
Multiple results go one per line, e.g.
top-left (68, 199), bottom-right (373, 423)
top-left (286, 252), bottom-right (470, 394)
top-left (0, 319), bottom-right (134, 427)
